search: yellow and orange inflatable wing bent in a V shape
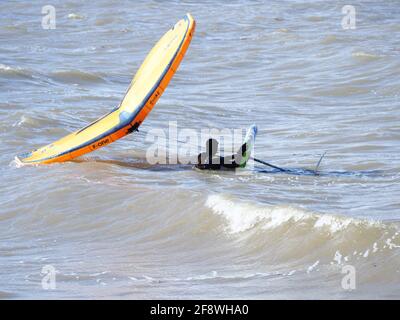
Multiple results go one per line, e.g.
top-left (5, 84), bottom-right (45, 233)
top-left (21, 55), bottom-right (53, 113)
top-left (16, 14), bottom-right (196, 164)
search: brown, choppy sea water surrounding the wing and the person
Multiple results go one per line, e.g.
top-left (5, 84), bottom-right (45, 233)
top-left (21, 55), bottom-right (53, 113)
top-left (0, 0), bottom-right (400, 299)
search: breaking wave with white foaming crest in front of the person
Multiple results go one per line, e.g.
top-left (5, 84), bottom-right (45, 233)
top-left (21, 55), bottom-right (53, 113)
top-left (206, 195), bottom-right (400, 277)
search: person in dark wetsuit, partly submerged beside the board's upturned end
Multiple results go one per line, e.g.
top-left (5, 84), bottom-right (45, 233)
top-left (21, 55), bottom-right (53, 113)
top-left (196, 138), bottom-right (246, 170)
